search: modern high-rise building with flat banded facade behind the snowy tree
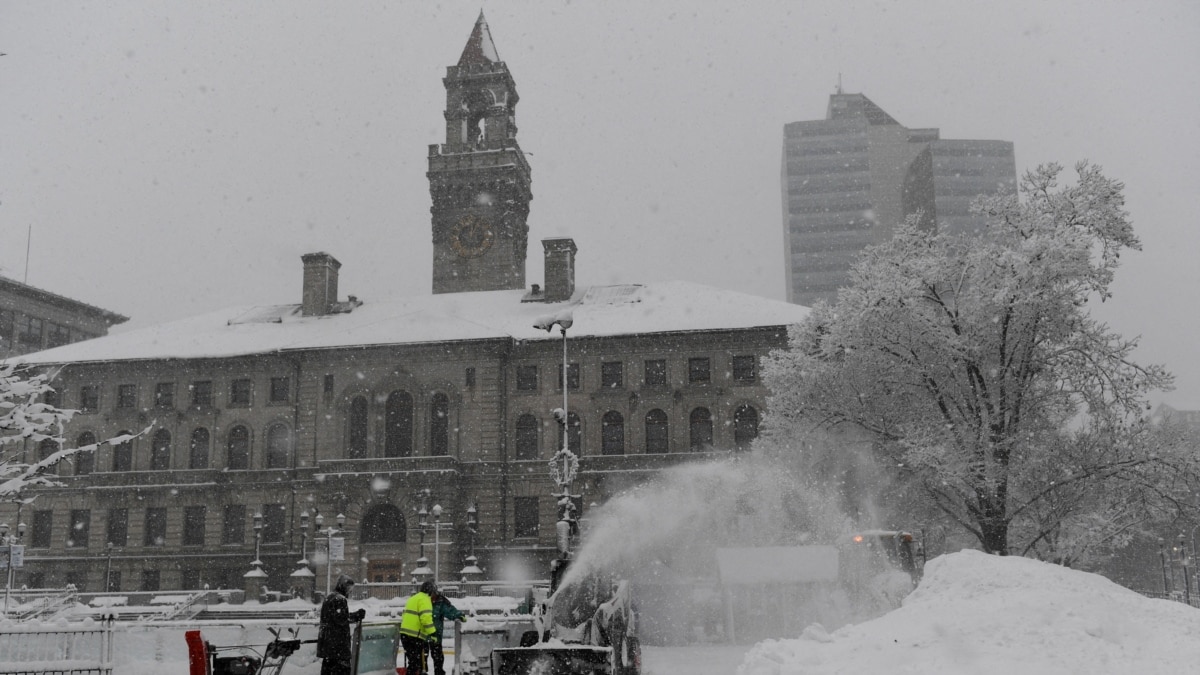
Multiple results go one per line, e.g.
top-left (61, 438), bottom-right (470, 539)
top-left (782, 92), bottom-right (1016, 305)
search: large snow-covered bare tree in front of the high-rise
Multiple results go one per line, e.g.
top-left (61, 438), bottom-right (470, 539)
top-left (764, 163), bottom-right (1195, 558)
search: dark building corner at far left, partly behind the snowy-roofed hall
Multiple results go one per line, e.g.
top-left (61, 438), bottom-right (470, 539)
top-left (0, 276), bottom-right (128, 358)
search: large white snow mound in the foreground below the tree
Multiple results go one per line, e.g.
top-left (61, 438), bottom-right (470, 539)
top-left (738, 551), bottom-right (1200, 675)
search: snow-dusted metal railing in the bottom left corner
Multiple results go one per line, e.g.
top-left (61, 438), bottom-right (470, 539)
top-left (0, 617), bottom-right (113, 675)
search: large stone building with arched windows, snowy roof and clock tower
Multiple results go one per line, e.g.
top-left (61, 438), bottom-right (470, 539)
top-left (0, 16), bottom-right (808, 591)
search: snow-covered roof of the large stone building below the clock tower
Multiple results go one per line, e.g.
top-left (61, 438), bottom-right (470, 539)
top-left (11, 281), bottom-right (809, 364)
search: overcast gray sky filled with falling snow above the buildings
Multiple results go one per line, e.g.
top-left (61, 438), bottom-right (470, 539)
top-left (0, 0), bottom-right (1200, 410)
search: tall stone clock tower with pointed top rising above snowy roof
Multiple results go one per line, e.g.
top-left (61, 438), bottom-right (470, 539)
top-left (426, 12), bottom-right (533, 293)
